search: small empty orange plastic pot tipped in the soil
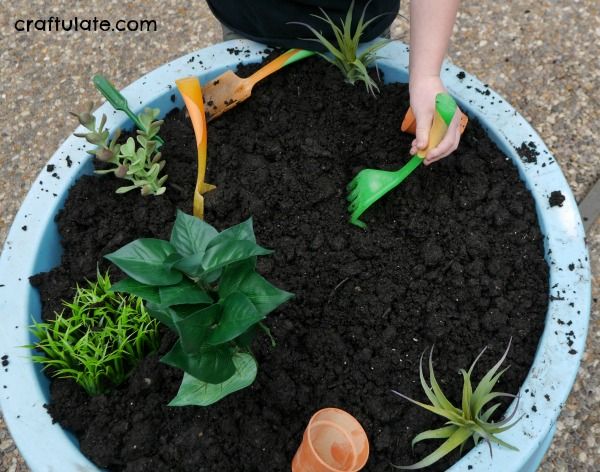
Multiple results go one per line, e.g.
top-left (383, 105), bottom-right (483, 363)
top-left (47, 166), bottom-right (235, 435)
top-left (292, 408), bottom-right (369, 472)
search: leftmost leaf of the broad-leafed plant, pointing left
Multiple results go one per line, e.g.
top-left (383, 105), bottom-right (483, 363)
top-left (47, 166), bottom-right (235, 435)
top-left (105, 238), bottom-right (183, 285)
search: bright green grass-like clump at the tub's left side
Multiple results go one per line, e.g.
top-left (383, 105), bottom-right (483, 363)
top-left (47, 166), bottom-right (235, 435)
top-left (27, 272), bottom-right (159, 395)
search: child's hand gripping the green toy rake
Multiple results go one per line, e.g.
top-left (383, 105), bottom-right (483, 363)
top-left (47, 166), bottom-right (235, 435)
top-left (409, 76), bottom-right (462, 165)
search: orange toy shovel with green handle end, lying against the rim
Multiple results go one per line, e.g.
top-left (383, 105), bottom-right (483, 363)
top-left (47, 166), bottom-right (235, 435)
top-left (204, 49), bottom-right (314, 121)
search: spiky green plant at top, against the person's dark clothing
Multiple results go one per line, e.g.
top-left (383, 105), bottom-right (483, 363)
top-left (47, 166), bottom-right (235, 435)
top-left (291, 0), bottom-right (390, 95)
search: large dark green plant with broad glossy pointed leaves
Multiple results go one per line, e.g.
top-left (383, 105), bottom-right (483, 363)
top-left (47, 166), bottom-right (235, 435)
top-left (106, 211), bottom-right (292, 406)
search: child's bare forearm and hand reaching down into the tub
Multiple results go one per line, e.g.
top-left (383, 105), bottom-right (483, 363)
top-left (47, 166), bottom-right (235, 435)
top-left (409, 0), bottom-right (461, 165)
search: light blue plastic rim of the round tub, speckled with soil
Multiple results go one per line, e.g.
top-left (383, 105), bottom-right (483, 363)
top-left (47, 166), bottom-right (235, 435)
top-left (0, 40), bottom-right (591, 472)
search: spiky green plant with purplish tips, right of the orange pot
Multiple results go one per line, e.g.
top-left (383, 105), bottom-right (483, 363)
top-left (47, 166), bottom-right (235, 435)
top-left (392, 341), bottom-right (521, 470)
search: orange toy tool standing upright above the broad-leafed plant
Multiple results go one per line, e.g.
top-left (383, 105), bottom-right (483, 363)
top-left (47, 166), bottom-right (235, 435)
top-left (175, 77), bottom-right (216, 219)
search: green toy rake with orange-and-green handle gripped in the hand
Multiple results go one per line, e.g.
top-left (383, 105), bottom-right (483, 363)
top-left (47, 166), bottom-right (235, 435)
top-left (348, 93), bottom-right (458, 228)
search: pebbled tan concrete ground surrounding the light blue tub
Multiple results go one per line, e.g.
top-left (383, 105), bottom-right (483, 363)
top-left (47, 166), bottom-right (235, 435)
top-left (0, 0), bottom-right (600, 472)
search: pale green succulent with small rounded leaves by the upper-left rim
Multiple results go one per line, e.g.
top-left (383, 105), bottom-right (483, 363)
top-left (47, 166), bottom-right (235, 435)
top-left (72, 103), bottom-right (168, 195)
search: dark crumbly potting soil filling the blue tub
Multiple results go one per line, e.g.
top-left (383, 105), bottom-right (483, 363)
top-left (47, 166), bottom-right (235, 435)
top-left (33, 53), bottom-right (548, 472)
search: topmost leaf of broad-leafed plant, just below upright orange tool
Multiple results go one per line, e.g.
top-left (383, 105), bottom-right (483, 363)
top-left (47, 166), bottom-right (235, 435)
top-left (171, 210), bottom-right (219, 256)
